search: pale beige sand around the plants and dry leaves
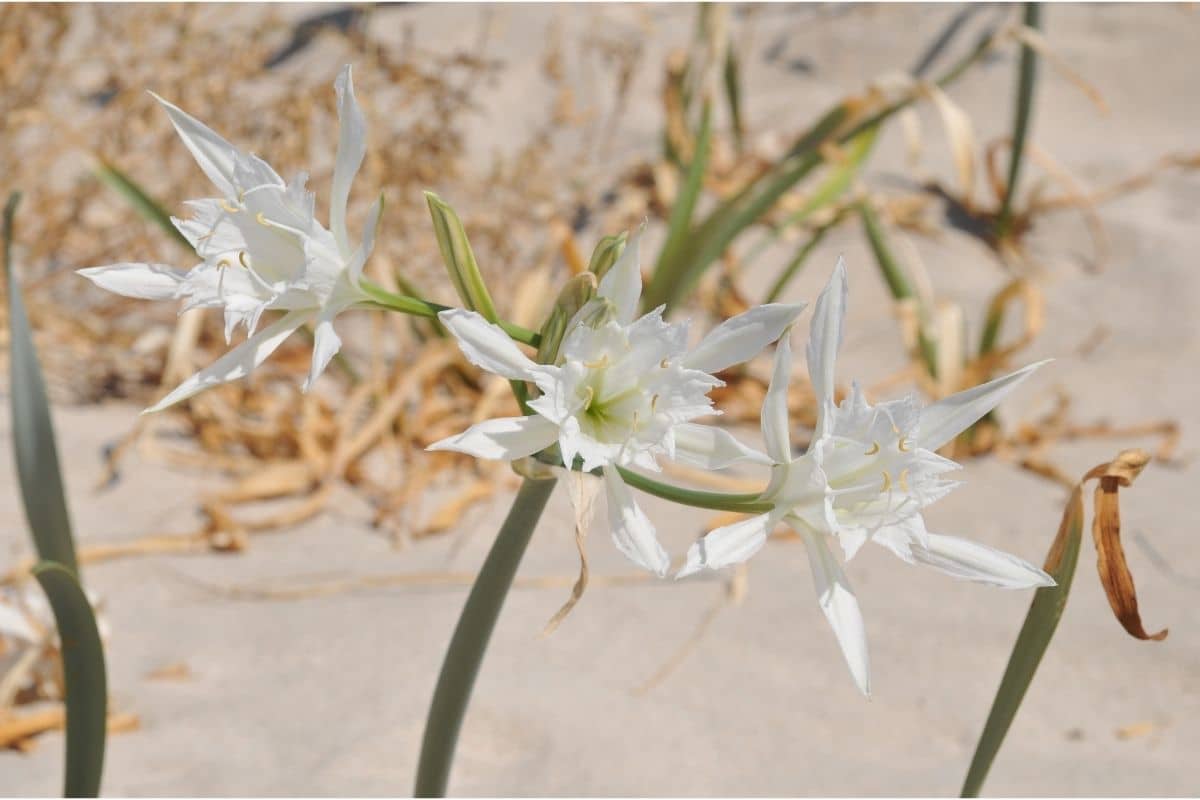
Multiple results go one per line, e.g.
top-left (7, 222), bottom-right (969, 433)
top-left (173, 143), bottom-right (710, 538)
top-left (0, 6), bottom-right (1200, 795)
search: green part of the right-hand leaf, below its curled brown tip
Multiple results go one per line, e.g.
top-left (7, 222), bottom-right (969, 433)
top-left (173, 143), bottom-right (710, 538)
top-left (962, 486), bottom-right (1084, 798)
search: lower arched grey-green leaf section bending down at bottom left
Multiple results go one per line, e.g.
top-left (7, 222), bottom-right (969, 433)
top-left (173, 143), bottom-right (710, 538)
top-left (34, 561), bottom-right (108, 798)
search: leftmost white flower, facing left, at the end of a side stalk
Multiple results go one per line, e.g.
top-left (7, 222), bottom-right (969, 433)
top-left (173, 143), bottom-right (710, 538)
top-left (79, 65), bottom-right (383, 411)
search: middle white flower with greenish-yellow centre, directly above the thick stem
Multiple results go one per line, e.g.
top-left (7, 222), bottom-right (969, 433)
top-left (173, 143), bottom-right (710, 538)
top-left (430, 231), bottom-right (804, 577)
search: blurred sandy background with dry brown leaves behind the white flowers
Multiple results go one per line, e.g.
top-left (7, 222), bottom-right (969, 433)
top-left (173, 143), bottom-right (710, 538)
top-left (0, 4), bottom-right (1200, 795)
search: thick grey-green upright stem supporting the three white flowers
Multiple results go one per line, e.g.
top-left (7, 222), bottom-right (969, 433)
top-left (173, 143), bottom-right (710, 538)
top-left (414, 479), bottom-right (556, 798)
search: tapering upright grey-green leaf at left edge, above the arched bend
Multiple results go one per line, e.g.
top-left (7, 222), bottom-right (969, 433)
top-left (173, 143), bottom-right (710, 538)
top-left (4, 192), bottom-right (79, 572)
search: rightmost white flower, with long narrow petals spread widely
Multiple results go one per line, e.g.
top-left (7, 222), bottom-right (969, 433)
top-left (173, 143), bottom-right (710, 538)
top-left (678, 260), bottom-right (1054, 694)
